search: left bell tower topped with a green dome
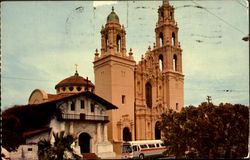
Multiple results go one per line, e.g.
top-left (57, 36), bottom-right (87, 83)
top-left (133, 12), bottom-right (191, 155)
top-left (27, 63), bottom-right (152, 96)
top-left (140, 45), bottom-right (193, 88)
top-left (93, 7), bottom-right (136, 154)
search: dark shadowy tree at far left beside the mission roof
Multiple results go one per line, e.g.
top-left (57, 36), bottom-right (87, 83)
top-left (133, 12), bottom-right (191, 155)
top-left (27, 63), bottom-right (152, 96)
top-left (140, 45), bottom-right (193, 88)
top-left (2, 102), bottom-right (61, 151)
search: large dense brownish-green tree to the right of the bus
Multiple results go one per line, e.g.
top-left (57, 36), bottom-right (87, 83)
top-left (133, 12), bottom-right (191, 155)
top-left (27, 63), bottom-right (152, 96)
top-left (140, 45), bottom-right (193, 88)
top-left (160, 102), bottom-right (249, 158)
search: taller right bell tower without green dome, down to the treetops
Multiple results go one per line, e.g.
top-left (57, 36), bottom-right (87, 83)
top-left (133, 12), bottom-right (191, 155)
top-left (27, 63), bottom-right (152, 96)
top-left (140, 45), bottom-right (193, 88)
top-left (154, 0), bottom-right (184, 111)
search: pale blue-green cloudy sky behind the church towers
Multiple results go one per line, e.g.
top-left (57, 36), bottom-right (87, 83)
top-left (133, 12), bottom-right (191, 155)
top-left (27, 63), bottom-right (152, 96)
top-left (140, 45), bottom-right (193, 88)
top-left (1, 0), bottom-right (249, 110)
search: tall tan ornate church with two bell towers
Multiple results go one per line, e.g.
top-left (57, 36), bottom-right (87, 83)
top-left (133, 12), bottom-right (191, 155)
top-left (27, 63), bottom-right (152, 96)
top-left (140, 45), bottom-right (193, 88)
top-left (93, 1), bottom-right (184, 153)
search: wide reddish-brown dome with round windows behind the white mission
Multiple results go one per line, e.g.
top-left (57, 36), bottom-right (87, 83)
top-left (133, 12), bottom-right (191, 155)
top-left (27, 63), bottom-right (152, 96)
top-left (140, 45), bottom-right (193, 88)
top-left (55, 70), bottom-right (95, 94)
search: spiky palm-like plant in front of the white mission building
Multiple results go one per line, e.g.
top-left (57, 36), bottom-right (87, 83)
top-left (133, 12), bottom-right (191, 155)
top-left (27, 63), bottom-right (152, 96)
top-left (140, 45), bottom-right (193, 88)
top-left (38, 131), bottom-right (80, 160)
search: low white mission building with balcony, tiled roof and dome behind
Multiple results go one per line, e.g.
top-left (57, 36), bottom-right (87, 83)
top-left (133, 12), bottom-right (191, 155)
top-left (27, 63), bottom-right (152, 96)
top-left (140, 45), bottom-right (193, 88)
top-left (10, 70), bottom-right (117, 159)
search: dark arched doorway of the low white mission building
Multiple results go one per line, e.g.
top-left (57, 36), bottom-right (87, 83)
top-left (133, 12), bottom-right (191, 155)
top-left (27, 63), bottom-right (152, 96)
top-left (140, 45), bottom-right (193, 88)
top-left (79, 133), bottom-right (91, 153)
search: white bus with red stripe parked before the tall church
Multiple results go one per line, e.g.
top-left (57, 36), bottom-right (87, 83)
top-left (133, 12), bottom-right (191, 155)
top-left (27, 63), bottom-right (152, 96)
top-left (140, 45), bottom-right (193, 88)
top-left (122, 140), bottom-right (167, 159)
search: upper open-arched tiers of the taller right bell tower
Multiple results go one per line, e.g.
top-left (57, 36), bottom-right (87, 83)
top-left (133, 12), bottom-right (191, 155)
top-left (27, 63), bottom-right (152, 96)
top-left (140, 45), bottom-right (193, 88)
top-left (155, 0), bottom-right (182, 72)
